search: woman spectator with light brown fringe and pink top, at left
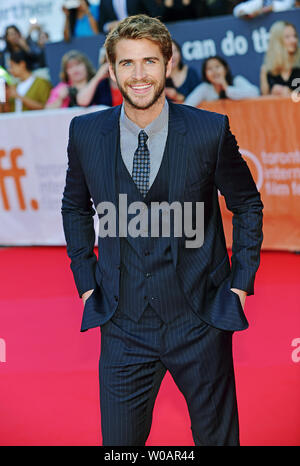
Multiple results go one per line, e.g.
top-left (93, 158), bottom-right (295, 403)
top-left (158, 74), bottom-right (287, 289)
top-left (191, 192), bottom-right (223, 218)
top-left (46, 50), bottom-right (95, 108)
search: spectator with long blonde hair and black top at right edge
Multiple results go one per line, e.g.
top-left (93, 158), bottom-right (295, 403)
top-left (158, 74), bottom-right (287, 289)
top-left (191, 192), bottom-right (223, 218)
top-left (260, 21), bottom-right (300, 96)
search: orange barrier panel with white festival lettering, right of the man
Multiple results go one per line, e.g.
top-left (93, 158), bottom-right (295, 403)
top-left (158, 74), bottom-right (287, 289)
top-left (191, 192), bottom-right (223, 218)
top-left (200, 97), bottom-right (300, 251)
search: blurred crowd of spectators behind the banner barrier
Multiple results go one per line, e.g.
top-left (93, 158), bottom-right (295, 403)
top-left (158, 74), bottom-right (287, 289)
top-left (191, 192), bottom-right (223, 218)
top-left (0, 0), bottom-right (300, 112)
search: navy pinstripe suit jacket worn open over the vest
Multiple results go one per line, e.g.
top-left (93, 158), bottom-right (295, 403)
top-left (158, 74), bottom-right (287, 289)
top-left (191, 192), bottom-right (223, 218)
top-left (62, 103), bottom-right (263, 331)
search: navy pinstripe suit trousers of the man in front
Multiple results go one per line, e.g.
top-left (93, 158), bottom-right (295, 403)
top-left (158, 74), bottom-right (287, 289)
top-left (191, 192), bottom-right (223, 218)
top-left (99, 305), bottom-right (239, 446)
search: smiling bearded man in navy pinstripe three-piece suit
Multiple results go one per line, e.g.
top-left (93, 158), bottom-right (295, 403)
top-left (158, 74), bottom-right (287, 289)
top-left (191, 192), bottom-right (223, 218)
top-left (62, 15), bottom-right (263, 445)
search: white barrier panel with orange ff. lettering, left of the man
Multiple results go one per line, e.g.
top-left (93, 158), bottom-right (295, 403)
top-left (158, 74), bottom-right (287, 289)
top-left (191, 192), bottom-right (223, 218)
top-left (0, 106), bottom-right (106, 246)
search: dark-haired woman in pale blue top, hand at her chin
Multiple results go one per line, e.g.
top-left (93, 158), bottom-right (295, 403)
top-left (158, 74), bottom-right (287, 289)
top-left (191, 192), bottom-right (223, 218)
top-left (184, 56), bottom-right (259, 107)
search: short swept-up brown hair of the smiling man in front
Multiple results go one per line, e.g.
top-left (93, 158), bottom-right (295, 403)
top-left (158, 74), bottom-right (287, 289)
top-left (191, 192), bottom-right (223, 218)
top-left (104, 15), bottom-right (172, 66)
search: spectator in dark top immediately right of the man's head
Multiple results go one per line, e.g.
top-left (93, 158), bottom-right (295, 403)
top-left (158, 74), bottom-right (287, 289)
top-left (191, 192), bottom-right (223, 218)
top-left (166, 40), bottom-right (200, 103)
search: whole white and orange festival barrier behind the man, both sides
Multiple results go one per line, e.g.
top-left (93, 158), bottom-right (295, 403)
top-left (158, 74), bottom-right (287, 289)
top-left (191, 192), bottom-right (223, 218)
top-left (0, 97), bottom-right (300, 251)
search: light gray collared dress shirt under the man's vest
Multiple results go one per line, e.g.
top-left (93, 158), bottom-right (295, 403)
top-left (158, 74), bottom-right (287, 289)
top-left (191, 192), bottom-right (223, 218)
top-left (120, 100), bottom-right (169, 189)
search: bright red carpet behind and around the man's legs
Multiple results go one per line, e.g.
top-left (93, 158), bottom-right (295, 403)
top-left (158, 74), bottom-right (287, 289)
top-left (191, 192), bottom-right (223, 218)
top-left (0, 247), bottom-right (300, 446)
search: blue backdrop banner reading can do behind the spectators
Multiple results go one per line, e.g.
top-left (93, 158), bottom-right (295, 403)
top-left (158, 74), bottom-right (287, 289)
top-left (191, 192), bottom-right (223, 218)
top-left (46, 8), bottom-right (300, 85)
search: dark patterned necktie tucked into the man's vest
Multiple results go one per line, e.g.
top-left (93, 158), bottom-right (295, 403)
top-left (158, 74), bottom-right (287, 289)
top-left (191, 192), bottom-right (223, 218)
top-left (132, 130), bottom-right (150, 197)
